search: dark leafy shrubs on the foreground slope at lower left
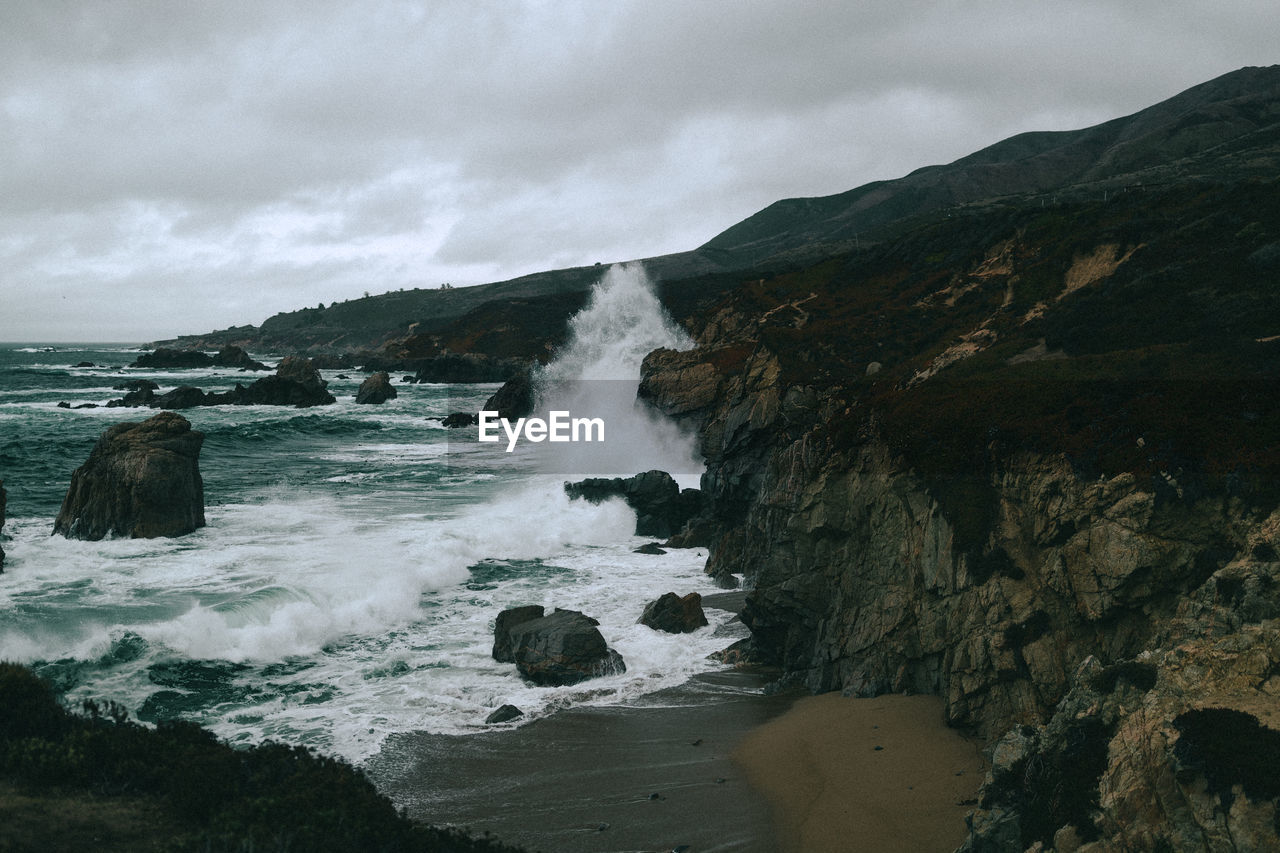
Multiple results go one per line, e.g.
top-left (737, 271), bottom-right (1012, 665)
top-left (0, 663), bottom-right (529, 853)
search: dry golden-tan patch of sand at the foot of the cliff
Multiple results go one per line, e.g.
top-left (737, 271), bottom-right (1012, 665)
top-left (733, 693), bottom-right (986, 853)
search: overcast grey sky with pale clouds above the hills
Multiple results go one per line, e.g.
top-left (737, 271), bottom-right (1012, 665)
top-left (0, 0), bottom-right (1280, 342)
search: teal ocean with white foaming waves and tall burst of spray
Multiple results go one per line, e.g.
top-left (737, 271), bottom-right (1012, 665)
top-left (0, 262), bottom-right (745, 763)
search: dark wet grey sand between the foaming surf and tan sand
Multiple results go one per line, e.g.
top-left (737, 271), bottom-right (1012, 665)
top-left (365, 672), bottom-right (795, 853)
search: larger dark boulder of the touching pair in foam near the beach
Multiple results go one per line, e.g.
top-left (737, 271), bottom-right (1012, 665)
top-left (495, 610), bottom-right (627, 686)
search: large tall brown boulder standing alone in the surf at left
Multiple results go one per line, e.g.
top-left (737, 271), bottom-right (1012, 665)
top-left (54, 411), bottom-right (205, 539)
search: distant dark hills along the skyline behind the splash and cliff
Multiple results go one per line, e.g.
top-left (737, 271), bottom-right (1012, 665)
top-left (157, 67), bottom-right (1280, 357)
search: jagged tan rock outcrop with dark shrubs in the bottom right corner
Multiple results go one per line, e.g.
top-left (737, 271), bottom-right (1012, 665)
top-left (961, 594), bottom-right (1280, 853)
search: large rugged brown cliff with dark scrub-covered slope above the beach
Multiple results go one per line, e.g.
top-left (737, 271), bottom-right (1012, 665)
top-left (641, 179), bottom-right (1280, 850)
